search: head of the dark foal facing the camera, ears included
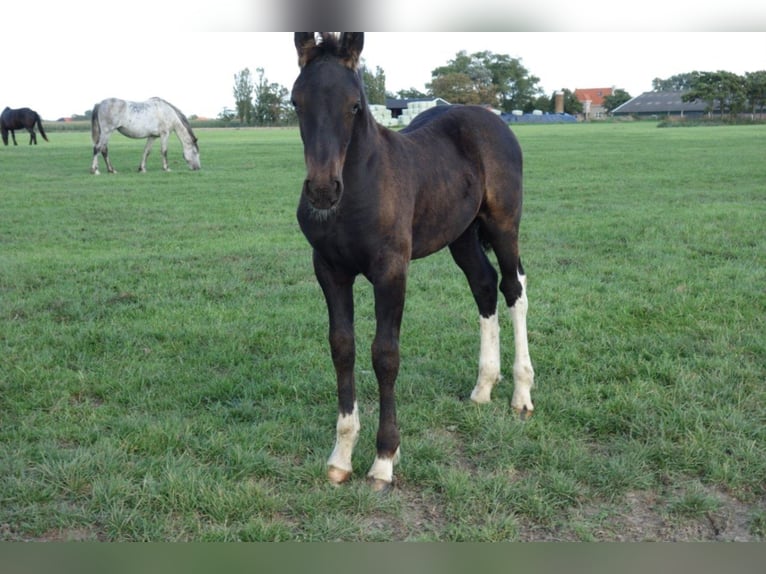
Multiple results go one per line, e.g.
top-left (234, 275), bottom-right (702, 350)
top-left (292, 32), bottom-right (367, 212)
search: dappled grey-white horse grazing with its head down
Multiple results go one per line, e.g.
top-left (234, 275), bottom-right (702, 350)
top-left (90, 98), bottom-right (200, 175)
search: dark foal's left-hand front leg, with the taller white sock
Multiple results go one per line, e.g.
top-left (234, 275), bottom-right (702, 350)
top-left (314, 252), bottom-right (360, 484)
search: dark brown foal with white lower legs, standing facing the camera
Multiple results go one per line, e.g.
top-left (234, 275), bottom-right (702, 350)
top-left (292, 32), bottom-right (534, 491)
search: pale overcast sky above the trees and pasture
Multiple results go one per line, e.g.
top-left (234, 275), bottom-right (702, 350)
top-left (0, 4), bottom-right (766, 120)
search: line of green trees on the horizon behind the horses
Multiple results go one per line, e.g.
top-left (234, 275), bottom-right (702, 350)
top-left (230, 57), bottom-right (766, 126)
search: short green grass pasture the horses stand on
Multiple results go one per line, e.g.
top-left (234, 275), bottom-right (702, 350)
top-left (0, 123), bottom-right (766, 541)
